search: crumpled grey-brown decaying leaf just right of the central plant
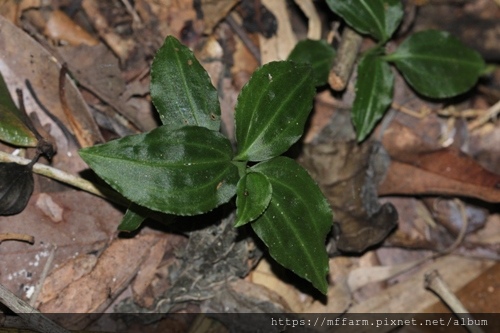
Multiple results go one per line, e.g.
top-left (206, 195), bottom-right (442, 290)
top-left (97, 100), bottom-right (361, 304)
top-left (301, 112), bottom-right (398, 252)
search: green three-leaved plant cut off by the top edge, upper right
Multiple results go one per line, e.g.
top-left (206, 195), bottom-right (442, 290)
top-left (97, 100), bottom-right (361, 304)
top-left (326, 0), bottom-right (485, 141)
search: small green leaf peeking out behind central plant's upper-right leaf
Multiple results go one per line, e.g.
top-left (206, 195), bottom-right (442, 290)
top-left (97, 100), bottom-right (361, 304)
top-left (288, 39), bottom-right (335, 87)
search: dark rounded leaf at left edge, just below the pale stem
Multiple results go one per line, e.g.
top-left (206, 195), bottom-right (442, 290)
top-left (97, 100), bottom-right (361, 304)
top-left (0, 163), bottom-right (34, 215)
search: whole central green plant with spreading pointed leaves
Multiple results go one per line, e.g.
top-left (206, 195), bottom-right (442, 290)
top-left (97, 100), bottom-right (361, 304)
top-left (80, 37), bottom-right (332, 293)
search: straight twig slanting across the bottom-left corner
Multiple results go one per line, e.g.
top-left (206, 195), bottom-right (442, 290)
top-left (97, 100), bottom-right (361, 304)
top-left (0, 284), bottom-right (69, 333)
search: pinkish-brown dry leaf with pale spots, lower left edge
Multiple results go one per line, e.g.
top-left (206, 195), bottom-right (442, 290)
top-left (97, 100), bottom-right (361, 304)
top-left (0, 190), bottom-right (123, 299)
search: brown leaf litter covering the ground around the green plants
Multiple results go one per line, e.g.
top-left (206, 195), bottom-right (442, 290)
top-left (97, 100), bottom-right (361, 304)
top-left (0, 0), bottom-right (500, 331)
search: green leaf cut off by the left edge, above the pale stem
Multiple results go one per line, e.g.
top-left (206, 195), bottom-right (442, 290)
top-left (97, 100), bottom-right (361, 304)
top-left (0, 74), bottom-right (38, 147)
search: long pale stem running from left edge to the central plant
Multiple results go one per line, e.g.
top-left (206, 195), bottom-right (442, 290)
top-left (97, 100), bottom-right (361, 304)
top-left (0, 151), bottom-right (130, 207)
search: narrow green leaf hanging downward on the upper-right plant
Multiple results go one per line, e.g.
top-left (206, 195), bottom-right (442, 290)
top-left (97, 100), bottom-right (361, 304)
top-left (352, 49), bottom-right (394, 141)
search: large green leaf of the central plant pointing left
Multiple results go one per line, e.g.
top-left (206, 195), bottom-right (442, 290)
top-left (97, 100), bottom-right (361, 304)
top-left (80, 126), bottom-right (239, 215)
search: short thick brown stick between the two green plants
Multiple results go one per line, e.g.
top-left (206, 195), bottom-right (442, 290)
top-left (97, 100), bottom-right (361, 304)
top-left (328, 27), bottom-right (363, 91)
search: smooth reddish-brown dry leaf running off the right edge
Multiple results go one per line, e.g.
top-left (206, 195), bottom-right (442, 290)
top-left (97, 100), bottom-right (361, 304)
top-left (378, 122), bottom-right (500, 202)
